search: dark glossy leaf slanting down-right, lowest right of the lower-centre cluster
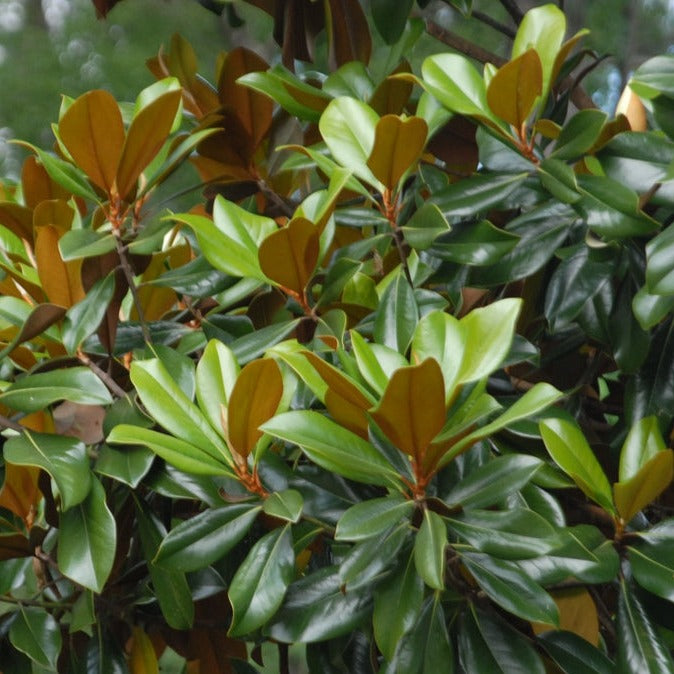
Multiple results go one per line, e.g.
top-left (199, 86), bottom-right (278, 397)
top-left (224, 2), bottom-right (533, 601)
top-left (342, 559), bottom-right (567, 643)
top-left (461, 552), bottom-right (559, 625)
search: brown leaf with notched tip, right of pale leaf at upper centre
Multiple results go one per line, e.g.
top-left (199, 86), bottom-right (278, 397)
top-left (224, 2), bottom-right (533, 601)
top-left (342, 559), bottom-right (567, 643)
top-left (367, 115), bottom-right (428, 190)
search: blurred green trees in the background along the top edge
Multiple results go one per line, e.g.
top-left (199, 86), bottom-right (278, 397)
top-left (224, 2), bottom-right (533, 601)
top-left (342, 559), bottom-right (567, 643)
top-left (0, 0), bottom-right (674, 178)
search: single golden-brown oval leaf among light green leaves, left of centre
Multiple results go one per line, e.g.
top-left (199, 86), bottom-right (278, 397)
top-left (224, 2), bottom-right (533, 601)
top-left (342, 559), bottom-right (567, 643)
top-left (227, 358), bottom-right (283, 458)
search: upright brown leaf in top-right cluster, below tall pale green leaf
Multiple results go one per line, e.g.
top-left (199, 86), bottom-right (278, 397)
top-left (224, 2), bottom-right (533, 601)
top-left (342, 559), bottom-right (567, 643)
top-left (487, 49), bottom-right (543, 131)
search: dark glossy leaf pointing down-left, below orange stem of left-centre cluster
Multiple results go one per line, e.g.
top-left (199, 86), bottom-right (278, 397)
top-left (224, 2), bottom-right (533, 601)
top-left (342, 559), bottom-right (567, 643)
top-left (154, 503), bottom-right (260, 571)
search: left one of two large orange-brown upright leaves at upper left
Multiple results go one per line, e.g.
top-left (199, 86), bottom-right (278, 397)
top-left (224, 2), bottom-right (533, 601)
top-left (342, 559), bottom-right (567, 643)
top-left (58, 89), bottom-right (125, 193)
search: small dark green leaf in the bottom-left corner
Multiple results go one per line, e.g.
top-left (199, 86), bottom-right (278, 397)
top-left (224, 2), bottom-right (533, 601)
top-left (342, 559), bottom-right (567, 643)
top-left (9, 606), bottom-right (62, 671)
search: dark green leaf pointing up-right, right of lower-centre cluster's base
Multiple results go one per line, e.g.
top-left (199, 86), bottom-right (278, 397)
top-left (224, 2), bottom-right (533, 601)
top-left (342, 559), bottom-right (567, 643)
top-left (443, 454), bottom-right (543, 509)
